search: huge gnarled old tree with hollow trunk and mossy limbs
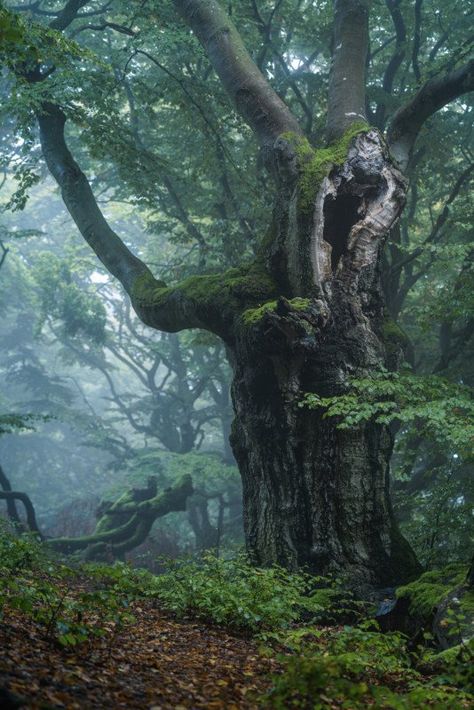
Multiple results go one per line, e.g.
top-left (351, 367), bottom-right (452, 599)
top-left (1, 0), bottom-right (474, 588)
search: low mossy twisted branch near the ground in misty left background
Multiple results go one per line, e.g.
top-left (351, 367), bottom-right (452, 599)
top-left (0, 472), bottom-right (193, 560)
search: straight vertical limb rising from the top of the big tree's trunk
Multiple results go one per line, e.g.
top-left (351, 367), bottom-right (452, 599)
top-left (327, 0), bottom-right (369, 141)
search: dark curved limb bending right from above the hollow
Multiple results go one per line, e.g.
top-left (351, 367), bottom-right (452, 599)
top-left (387, 59), bottom-right (474, 168)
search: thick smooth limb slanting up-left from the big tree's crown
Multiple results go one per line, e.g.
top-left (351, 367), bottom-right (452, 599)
top-left (174, 0), bottom-right (301, 145)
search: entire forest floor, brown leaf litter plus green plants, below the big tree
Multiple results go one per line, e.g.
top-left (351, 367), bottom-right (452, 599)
top-left (0, 530), bottom-right (474, 709)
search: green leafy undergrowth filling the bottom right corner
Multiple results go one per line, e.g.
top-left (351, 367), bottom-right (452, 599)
top-left (265, 622), bottom-right (472, 710)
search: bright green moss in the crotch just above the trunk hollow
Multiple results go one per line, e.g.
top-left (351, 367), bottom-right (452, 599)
top-left (281, 121), bottom-right (370, 212)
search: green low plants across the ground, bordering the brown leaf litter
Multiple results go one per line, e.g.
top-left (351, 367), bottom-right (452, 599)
top-left (0, 528), bottom-right (473, 710)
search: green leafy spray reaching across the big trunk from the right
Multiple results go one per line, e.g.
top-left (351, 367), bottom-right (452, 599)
top-left (301, 370), bottom-right (474, 456)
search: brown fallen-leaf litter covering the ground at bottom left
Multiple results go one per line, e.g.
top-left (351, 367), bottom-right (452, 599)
top-left (0, 602), bottom-right (278, 710)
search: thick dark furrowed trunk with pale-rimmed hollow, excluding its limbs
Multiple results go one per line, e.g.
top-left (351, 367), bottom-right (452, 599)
top-left (232, 132), bottom-right (418, 590)
